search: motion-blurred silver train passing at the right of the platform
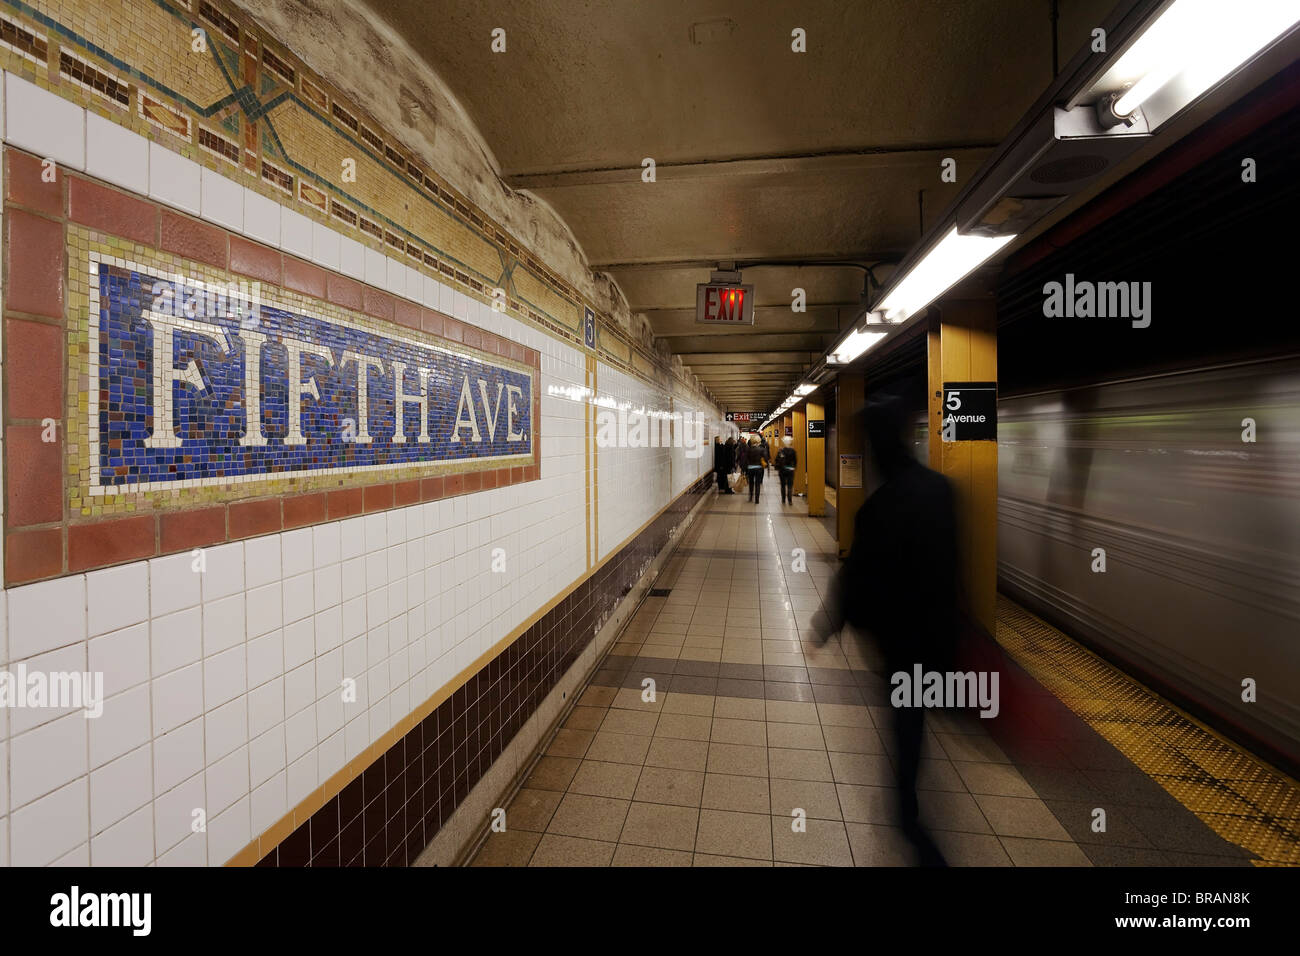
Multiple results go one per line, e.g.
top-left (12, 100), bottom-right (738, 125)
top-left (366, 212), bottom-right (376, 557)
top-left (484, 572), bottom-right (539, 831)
top-left (982, 356), bottom-right (1300, 766)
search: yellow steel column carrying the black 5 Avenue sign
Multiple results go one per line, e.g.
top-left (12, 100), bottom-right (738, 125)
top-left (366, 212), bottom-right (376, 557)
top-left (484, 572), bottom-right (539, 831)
top-left (928, 299), bottom-right (997, 633)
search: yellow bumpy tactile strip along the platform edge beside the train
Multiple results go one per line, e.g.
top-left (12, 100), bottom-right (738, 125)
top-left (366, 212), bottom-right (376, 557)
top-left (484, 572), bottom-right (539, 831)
top-left (997, 594), bottom-right (1300, 866)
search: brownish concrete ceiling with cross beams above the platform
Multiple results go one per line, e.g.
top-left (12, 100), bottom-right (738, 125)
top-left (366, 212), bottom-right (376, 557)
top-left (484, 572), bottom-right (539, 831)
top-left (365, 0), bottom-right (1113, 410)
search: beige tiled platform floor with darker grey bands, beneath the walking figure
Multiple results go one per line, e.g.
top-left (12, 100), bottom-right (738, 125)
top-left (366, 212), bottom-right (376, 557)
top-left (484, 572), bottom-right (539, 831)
top-left (473, 488), bottom-right (1279, 866)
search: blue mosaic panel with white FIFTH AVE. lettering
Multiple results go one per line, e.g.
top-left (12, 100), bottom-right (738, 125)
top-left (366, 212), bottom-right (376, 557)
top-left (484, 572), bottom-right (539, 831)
top-left (87, 255), bottom-right (534, 496)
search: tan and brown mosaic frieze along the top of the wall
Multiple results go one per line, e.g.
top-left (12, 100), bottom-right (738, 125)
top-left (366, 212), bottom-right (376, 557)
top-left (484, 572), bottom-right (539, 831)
top-left (0, 0), bottom-right (707, 408)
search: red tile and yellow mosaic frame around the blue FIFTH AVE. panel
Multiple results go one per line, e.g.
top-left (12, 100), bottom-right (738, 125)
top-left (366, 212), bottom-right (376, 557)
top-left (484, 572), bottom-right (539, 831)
top-left (4, 148), bottom-right (541, 587)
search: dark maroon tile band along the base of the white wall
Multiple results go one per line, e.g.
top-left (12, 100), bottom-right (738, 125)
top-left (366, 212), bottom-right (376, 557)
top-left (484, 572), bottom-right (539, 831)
top-left (257, 475), bottom-right (714, 866)
